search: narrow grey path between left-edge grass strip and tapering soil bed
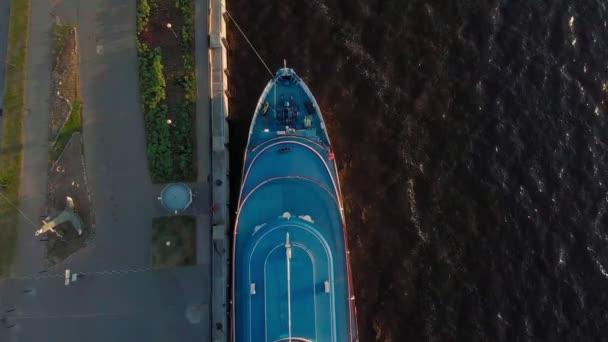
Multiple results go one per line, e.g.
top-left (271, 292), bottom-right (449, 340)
top-left (15, 0), bottom-right (53, 274)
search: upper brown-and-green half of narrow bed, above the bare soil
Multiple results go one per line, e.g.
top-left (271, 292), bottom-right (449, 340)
top-left (49, 25), bottom-right (79, 144)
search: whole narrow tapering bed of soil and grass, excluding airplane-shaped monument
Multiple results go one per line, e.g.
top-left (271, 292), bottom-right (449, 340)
top-left (46, 23), bottom-right (94, 264)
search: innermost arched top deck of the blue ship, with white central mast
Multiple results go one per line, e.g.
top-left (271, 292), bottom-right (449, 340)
top-left (248, 220), bottom-right (335, 341)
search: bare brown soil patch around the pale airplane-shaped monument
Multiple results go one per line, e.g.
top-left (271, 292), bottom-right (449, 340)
top-left (47, 133), bottom-right (94, 264)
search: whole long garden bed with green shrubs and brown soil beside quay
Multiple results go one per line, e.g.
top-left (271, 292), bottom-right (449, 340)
top-left (137, 0), bottom-right (197, 183)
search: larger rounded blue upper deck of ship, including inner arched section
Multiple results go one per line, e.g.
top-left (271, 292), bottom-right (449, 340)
top-left (236, 177), bottom-right (349, 341)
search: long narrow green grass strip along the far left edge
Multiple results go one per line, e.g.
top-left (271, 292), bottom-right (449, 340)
top-left (0, 0), bottom-right (30, 276)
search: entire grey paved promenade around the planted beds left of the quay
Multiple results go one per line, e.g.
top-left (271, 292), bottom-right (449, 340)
top-left (0, 0), bottom-right (210, 342)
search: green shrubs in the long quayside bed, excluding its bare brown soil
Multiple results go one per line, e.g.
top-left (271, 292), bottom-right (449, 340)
top-left (137, 0), bottom-right (196, 183)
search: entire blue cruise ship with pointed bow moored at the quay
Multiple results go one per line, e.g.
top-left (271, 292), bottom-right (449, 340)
top-left (231, 67), bottom-right (358, 342)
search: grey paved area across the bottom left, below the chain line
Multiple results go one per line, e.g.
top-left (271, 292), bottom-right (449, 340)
top-left (0, 266), bottom-right (209, 342)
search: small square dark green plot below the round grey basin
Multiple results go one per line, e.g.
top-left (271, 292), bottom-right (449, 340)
top-left (152, 216), bottom-right (196, 267)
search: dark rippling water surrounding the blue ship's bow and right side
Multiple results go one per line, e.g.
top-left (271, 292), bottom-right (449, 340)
top-left (229, 0), bottom-right (608, 341)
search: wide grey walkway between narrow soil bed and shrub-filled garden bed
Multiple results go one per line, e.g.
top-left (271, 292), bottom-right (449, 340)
top-left (65, 0), bottom-right (165, 268)
